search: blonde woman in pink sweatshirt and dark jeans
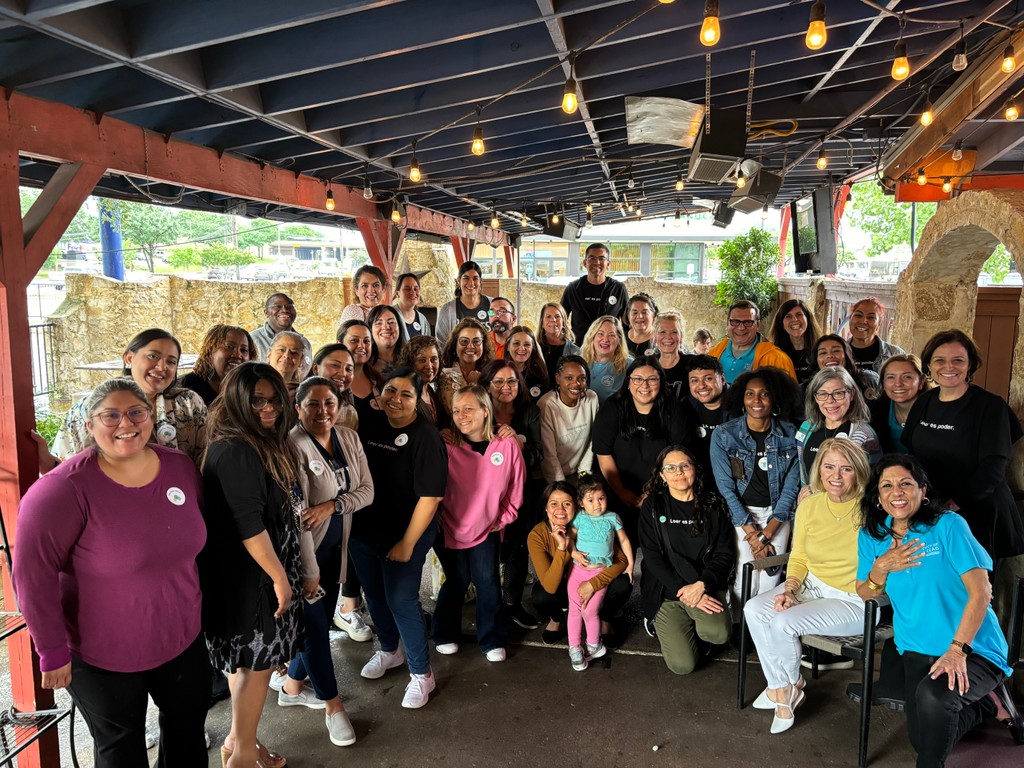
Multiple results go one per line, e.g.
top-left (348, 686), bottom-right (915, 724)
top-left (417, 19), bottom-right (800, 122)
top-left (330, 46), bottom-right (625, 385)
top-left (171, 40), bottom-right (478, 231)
top-left (432, 384), bottom-right (526, 662)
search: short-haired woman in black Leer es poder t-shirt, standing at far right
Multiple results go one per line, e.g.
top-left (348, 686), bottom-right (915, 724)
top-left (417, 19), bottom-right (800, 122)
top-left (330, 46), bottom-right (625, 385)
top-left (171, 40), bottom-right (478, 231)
top-left (900, 329), bottom-right (1024, 559)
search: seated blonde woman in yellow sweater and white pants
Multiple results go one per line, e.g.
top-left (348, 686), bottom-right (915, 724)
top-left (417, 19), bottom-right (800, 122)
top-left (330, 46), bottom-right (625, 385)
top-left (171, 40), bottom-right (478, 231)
top-left (743, 438), bottom-right (870, 733)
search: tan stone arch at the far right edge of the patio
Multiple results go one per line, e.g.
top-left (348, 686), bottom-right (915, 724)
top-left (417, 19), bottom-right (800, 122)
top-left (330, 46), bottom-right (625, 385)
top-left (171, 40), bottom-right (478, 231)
top-left (893, 189), bottom-right (1024, 487)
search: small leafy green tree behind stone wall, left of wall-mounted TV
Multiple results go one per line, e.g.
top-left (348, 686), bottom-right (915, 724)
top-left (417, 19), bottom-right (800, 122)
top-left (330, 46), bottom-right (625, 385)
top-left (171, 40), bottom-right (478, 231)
top-left (715, 228), bottom-right (778, 315)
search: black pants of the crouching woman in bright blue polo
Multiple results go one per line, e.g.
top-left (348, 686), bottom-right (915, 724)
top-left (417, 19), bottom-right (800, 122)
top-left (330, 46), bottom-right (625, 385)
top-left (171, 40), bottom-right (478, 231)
top-left (896, 651), bottom-right (1006, 768)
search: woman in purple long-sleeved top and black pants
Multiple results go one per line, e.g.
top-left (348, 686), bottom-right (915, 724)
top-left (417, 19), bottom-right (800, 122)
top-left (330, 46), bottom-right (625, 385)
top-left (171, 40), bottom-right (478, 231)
top-left (13, 379), bottom-right (210, 768)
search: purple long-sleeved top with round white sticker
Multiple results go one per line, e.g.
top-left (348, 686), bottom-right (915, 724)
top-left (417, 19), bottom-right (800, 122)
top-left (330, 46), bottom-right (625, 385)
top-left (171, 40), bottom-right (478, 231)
top-left (13, 445), bottom-right (206, 672)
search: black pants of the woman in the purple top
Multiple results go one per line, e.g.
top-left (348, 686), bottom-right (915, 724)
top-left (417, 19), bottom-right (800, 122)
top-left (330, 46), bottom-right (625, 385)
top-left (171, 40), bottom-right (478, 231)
top-left (68, 633), bottom-right (210, 768)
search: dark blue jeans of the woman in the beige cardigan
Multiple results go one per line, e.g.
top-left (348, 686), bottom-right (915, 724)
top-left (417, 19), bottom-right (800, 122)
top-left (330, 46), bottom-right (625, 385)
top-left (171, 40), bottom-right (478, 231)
top-left (288, 515), bottom-right (344, 701)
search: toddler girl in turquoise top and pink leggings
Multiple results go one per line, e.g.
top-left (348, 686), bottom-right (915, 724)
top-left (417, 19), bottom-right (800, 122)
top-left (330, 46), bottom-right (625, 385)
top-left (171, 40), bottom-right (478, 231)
top-left (567, 475), bottom-right (633, 672)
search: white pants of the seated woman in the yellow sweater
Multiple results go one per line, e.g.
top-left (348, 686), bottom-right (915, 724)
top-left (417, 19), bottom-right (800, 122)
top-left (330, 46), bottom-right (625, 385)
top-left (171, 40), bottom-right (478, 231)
top-left (743, 572), bottom-right (864, 688)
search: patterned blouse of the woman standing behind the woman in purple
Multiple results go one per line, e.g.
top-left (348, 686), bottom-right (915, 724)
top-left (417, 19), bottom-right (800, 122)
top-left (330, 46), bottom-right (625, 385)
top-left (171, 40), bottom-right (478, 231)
top-left (52, 386), bottom-right (206, 466)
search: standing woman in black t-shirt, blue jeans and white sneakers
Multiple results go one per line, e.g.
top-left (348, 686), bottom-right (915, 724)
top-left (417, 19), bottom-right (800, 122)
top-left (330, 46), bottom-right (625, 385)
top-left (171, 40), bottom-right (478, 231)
top-left (348, 368), bottom-right (447, 709)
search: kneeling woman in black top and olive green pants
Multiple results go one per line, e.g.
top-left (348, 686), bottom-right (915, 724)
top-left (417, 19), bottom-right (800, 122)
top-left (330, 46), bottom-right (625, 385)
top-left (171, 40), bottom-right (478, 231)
top-left (639, 445), bottom-right (735, 675)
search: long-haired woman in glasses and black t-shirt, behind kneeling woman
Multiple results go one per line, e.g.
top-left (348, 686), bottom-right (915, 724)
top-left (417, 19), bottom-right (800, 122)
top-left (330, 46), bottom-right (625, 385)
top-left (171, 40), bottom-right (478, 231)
top-left (593, 357), bottom-right (694, 545)
